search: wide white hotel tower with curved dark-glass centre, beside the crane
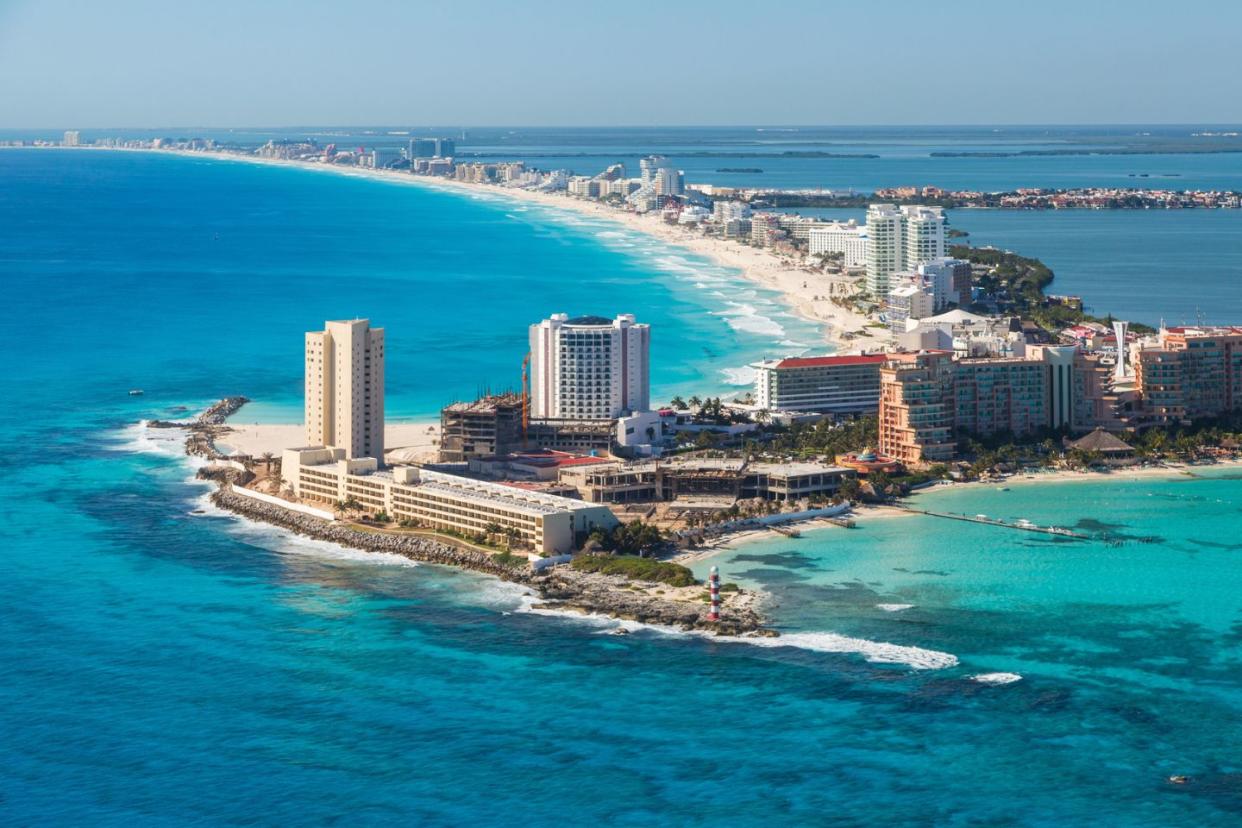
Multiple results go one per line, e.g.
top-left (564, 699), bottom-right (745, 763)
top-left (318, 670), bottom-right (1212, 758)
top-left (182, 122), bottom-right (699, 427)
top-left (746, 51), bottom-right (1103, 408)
top-left (530, 313), bottom-right (651, 420)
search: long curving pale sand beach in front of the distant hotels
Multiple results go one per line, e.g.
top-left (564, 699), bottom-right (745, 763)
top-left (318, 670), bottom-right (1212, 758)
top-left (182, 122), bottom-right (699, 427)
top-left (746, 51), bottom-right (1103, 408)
top-left (48, 146), bottom-right (889, 358)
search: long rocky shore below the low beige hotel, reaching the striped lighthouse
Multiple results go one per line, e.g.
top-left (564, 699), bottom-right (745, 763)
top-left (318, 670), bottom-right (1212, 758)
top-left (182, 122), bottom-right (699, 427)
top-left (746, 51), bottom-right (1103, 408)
top-left (211, 485), bottom-right (777, 636)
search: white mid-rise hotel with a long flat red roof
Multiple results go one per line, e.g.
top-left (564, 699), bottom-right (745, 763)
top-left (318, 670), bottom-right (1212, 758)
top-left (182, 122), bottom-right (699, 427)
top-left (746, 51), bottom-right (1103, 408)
top-left (751, 354), bottom-right (888, 415)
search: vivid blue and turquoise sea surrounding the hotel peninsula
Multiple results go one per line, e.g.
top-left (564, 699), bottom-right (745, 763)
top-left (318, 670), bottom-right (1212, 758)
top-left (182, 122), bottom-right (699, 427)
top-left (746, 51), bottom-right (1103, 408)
top-left (0, 150), bottom-right (1242, 826)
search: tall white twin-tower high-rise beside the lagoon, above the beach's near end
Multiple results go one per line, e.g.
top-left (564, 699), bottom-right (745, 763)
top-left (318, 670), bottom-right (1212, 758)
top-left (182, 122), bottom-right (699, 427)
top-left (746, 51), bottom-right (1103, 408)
top-left (867, 204), bottom-right (946, 299)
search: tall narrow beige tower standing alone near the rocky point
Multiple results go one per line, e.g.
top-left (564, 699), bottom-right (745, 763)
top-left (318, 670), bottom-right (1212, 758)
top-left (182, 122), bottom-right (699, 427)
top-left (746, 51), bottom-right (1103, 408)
top-left (306, 319), bottom-right (384, 466)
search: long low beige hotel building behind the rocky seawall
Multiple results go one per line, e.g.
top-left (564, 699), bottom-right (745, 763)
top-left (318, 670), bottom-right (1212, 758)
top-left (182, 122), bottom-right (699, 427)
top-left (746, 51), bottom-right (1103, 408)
top-left (281, 446), bottom-right (617, 555)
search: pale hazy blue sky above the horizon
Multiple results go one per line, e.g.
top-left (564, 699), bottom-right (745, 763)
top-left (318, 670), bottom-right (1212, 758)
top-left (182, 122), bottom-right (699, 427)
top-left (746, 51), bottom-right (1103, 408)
top-left (0, 0), bottom-right (1242, 129)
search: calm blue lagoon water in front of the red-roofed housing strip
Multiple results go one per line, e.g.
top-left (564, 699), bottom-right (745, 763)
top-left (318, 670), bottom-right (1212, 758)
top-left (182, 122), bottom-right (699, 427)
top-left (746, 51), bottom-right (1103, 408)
top-left (797, 209), bottom-right (1242, 325)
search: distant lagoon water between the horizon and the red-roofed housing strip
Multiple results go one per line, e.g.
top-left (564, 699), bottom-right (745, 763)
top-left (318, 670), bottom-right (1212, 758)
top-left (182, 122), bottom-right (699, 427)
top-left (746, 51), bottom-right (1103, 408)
top-left (12, 124), bottom-right (1242, 192)
